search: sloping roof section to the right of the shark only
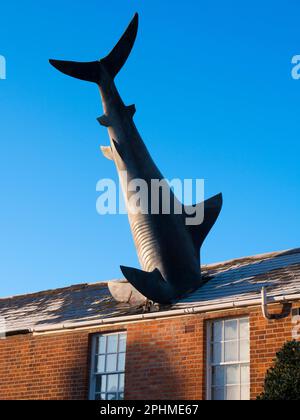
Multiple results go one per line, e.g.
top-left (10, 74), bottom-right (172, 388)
top-left (177, 248), bottom-right (300, 306)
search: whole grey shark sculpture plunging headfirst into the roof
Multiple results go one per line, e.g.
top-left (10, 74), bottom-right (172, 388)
top-left (50, 14), bottom-right (222, 304)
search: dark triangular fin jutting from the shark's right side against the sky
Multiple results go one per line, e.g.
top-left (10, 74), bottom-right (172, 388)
top-left (185, 194), bottom-right (223, 252)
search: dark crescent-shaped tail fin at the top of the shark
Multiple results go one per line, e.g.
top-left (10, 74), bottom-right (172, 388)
top-left (49, 13), bottom-right (139, 85)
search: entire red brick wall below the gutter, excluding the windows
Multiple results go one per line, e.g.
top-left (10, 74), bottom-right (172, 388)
top-left (0, 308), bottom-right (292, 400)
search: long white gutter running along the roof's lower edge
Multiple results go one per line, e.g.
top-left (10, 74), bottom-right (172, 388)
top-left (6, 294), bottom-right (300, 336)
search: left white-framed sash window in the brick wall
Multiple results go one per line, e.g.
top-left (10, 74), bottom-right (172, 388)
top-left (90, 333), bottom-right (127, 401)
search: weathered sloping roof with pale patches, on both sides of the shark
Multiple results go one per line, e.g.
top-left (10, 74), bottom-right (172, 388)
top-left (0, 249), bottom-right (300, 331)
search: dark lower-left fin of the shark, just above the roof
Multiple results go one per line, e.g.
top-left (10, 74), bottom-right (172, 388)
top-left (121, 266), bottom-right (172, 304)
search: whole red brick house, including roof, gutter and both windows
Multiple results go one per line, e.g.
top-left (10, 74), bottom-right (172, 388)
top-left (0, 249), bottom-right (300, 400)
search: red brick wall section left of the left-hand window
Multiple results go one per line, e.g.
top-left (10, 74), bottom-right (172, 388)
top-left (0, 333), bottom-right (88, 399)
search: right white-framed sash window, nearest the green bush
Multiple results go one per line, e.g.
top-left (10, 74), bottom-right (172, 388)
top-left (207, 318), bottom-right (250, 400)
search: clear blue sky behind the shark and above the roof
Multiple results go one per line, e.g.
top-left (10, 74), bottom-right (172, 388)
top-left (0, 0), bottom-right (300, 296)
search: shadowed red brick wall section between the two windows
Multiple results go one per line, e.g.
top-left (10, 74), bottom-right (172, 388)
top-left (126, 316), bottom-right (205, 400)
